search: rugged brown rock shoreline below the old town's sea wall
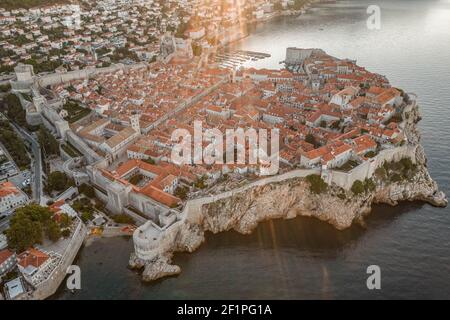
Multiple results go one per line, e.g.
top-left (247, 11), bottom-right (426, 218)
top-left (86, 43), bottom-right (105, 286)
top-left (129, 103), bottom-right (448, 281)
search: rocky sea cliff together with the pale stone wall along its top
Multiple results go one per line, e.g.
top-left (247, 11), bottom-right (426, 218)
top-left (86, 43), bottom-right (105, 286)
top-left (129, 104), bottom-right (448, 281)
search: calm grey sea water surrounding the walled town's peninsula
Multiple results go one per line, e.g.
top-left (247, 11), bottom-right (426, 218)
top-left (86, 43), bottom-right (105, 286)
top-left (44, 2), bottom-right (450, 299)
